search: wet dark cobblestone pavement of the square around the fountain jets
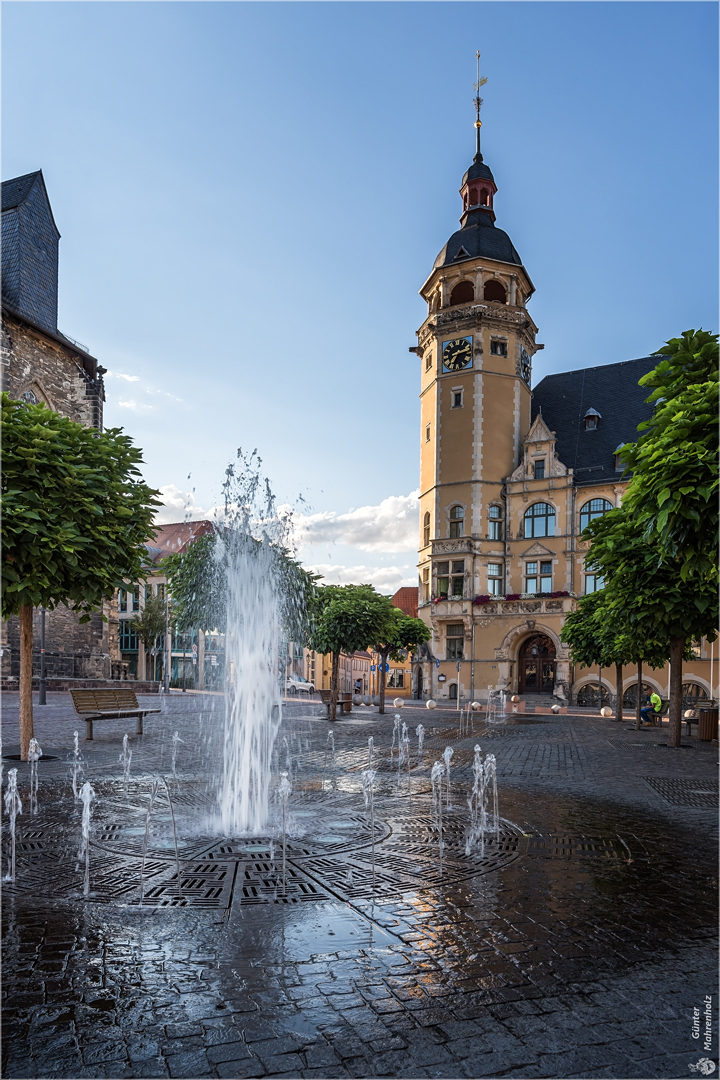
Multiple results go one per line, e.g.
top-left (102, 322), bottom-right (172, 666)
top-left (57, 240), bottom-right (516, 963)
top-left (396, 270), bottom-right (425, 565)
top-left (2, 694), bottom-right (718, 1078)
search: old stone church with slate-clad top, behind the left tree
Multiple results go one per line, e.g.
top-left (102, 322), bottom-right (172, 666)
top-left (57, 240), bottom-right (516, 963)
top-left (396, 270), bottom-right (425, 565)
top-left (0, 172), bottom-right (117, 679)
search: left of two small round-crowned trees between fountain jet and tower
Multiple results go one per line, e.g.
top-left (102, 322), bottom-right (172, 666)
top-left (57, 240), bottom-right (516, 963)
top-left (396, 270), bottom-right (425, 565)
top-left (307, 585), bottom-right (397, 720)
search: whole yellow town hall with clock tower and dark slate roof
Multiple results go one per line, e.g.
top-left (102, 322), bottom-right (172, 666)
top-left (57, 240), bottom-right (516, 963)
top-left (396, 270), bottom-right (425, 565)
top-left (410, 145), bottom-right (717, 705)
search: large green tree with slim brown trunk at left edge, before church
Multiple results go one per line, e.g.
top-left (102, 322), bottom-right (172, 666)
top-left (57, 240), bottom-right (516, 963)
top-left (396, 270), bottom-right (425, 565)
top-left (2, 393), bottom-right (160, 760)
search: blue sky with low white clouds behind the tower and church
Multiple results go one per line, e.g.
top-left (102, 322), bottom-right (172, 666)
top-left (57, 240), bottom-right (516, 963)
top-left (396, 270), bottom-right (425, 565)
top-left (2, 0), bottom-right (718, 590)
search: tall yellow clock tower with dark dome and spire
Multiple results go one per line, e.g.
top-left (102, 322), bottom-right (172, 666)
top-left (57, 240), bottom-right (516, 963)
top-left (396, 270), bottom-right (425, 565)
top-left (412, 79), bottom-right (543, 692)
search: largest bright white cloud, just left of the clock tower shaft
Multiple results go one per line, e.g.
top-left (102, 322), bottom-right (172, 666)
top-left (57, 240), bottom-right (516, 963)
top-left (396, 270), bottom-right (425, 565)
top-left (296, 491), bottom-right (419, 552)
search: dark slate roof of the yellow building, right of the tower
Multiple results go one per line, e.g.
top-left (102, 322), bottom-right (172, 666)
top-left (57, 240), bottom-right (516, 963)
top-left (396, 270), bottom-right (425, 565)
top-left (532, 356), bottom-right (661, 484)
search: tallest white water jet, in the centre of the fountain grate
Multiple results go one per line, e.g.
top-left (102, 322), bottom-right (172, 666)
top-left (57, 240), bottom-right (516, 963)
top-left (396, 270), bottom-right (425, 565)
top-left (215, 450), bottom-right (304, 835)
